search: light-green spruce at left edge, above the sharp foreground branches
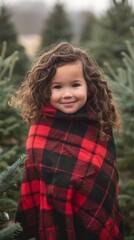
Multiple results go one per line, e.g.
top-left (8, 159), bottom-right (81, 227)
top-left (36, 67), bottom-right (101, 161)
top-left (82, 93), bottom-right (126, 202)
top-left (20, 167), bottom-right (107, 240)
top-left (0, 43), bottom-right (26, 170)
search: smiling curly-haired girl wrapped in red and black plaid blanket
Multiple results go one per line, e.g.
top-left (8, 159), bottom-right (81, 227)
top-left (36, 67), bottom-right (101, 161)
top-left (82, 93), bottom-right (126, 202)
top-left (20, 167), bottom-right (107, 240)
top-left (10, 43), bottom-right (123, 240)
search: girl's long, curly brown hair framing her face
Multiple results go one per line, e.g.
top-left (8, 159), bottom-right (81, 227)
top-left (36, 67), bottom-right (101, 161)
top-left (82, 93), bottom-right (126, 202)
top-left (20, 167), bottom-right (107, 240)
top-left (9, 42), bottom-right (120, 138)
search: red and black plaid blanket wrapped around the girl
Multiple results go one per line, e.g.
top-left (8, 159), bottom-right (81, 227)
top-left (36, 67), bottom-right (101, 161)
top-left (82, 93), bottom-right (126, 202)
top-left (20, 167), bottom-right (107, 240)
top-left (16, 105), bottom-right (123, 240)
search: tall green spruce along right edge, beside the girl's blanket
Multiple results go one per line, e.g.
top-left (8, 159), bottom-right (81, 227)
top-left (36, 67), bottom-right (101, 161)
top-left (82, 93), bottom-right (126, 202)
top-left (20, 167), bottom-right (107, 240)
top-left (105, 28), bottom-right (134, 236)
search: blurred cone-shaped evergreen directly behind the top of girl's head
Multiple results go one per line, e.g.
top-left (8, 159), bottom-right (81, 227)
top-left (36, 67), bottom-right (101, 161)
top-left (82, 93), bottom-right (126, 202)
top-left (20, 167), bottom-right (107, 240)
top-left (41, 3), bottom-right (72, 49)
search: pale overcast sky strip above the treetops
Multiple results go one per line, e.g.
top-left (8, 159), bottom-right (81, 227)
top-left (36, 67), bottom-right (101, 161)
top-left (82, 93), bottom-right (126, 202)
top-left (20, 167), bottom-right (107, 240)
top-left (3, 0), bottom-right (134, 14)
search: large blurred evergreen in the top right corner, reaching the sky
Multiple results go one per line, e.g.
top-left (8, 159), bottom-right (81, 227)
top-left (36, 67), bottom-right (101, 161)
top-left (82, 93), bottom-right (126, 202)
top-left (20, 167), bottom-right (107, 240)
top-left (81, 0), bottom-right (134, 70)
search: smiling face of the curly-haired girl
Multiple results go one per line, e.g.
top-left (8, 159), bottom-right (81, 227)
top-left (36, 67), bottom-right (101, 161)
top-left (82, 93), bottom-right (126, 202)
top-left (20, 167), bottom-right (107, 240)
top-left (50, 61), bottom-right (87, 114)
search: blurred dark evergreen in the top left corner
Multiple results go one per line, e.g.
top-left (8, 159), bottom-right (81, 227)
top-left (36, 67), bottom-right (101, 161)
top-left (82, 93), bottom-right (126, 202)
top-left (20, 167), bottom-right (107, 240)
top-left (0, 4), bottom-right (30, 83)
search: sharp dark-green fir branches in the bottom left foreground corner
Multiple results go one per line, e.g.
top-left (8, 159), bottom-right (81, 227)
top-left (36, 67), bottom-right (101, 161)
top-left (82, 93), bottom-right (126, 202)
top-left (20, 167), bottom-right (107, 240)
top-left (0, 155), bottom-right (25, 240)
